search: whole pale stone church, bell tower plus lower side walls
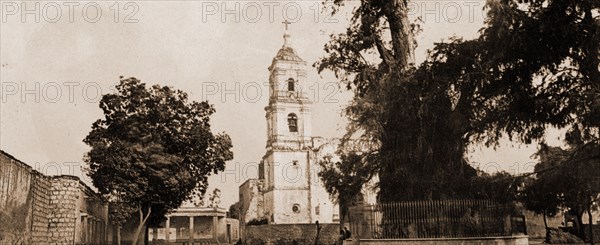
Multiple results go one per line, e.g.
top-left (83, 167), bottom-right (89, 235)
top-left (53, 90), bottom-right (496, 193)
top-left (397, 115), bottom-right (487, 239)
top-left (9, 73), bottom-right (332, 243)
top-left (239, 27), bottom-right (374, 226)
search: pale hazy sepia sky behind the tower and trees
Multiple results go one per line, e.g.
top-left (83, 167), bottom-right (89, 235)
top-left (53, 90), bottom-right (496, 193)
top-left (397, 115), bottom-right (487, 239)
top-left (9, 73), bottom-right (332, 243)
top-left (0, 0), bottom-right (560, 207)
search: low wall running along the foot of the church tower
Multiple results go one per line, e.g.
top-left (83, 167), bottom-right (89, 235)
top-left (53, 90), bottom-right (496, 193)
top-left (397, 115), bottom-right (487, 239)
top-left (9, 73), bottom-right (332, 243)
top-left (242, 224), bottom-right (340, 245)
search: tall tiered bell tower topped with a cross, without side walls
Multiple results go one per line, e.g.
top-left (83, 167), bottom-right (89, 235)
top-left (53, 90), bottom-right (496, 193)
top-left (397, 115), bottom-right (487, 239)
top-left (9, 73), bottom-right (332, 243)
top-left (261, 21), bottom-right (312, 224)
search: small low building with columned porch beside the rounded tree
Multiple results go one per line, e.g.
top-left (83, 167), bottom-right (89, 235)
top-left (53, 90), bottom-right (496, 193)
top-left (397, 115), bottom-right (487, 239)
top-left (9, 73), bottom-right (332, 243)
top-left (148, 205), bottom-right (240, 244)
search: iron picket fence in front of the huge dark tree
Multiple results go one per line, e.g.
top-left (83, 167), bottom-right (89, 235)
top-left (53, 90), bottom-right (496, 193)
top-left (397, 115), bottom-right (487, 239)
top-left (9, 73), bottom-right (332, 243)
top-left (348, 200), bottom-right (527, 239)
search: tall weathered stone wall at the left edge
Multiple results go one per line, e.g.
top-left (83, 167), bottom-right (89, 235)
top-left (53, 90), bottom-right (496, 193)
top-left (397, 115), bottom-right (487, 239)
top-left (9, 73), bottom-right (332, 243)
top-left (0, 150), bottom-right (108, 245)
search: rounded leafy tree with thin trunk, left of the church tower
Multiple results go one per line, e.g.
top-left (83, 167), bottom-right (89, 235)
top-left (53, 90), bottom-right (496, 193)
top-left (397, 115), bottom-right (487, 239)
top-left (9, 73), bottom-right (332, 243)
top-left (84, 77), bottom-right (233, 244)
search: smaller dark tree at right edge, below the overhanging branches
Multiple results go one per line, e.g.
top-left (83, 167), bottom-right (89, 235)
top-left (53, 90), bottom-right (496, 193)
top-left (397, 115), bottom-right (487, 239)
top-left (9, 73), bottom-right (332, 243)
top-left (524, 142), bottom-right (600, 243)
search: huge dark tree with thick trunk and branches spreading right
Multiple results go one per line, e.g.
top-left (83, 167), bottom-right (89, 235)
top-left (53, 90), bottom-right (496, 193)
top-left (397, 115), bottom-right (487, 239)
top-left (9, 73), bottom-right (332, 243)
top-left (316, 0), bottom-right (600, 201)
